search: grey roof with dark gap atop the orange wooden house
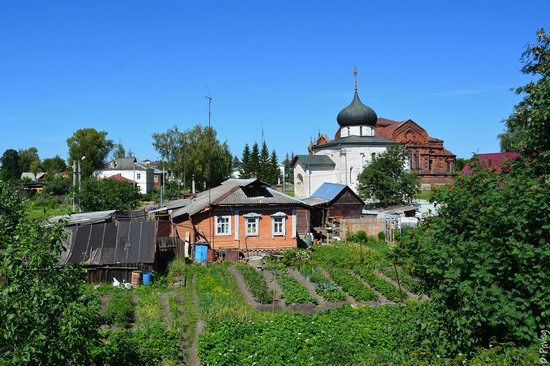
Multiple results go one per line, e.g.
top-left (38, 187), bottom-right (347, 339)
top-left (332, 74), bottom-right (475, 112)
top-left (171, 178), bottom-right (303, 217)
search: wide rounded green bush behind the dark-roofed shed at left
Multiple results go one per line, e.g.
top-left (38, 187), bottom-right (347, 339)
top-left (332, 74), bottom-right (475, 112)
top-left (77, 178), bottom-right (141, 211)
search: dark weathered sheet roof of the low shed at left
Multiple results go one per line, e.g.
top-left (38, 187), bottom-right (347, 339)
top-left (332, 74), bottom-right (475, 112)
top-left (60, 220), bottom-right (157, 266)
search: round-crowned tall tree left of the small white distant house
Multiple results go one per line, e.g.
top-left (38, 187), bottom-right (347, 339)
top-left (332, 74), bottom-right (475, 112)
top-left (67, 128), bottom-right (113, 178)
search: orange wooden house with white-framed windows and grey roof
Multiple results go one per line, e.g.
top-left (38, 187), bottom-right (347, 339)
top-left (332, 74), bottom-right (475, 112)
top-left (169, 179), bottom-right (310, 253)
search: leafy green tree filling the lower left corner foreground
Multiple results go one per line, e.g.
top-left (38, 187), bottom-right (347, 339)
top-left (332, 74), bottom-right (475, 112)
top-left (0, 182), bottom-right (99, 365)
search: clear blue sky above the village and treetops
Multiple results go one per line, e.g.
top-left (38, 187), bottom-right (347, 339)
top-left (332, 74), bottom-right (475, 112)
top-left (0, 0), bottom-right (550, 159)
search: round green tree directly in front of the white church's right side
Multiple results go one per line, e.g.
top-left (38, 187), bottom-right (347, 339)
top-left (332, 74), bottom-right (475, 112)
top-left (359, 145), bottom-right (420, 207)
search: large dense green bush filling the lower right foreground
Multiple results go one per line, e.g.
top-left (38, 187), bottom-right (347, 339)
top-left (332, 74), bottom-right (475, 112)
top-left (398, 159), bottom-right (550, 349)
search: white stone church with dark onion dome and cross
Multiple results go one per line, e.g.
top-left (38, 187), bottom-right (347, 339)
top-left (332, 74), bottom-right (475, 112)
top-left (292, 71), bottom-right (396, 198)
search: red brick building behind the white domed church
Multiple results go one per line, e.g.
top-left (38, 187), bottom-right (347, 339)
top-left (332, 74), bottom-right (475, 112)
top-left (376, 118), bottom-right (456, 188)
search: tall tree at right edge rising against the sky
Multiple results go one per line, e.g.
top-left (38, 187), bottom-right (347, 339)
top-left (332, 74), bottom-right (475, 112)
top-left (499, 29), bottom-right (550, 160)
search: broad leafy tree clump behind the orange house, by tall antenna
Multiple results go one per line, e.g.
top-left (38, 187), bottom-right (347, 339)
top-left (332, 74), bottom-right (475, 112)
top-left (153, 124), bottom-right (232, 189)
